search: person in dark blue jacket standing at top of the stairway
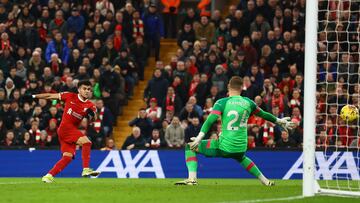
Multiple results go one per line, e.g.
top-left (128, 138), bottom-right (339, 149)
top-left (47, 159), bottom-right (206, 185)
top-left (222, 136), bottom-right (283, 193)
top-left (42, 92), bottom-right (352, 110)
top-left (142, 3), bottom-right (164, 61)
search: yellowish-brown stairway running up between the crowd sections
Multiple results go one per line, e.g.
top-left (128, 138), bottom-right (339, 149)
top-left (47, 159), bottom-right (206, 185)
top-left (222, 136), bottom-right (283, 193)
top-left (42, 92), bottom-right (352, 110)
top-left (113, 39), bottom-right (178, 149)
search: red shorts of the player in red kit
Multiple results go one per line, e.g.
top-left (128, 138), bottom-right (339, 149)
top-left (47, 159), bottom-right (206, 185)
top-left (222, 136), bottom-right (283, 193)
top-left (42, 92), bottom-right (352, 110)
top-left (58, 128), bottom-right (84, 156)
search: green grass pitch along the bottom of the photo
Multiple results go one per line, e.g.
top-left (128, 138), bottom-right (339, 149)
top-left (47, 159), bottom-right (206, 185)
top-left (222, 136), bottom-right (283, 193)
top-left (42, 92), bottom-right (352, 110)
top-left (0, 178), bottom-right (360, 203)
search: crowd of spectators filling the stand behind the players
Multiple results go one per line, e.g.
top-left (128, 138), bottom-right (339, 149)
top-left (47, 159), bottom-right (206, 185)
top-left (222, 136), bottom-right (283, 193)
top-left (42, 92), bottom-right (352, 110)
top-left (0, 0), bottom-right (360, 150)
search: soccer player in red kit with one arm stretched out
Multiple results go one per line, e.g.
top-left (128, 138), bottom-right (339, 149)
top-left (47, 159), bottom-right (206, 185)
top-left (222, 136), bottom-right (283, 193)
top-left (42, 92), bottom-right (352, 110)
top-left (33, 80), bottom-right (100, 183)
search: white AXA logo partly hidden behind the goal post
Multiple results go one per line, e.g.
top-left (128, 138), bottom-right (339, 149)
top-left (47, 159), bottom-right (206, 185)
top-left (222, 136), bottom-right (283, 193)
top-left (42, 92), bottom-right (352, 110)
top-left (283, 152), bottom-right (360, 180)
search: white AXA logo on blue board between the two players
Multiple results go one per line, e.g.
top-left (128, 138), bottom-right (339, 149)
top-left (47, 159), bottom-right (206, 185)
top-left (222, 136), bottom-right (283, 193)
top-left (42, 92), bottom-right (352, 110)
top-left (96, 150), bottom-right (165, 178)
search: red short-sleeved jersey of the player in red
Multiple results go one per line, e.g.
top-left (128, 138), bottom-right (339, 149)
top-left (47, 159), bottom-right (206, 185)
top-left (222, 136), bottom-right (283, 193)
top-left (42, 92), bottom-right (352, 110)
top-left (59, 92), bottom-right (96, 128)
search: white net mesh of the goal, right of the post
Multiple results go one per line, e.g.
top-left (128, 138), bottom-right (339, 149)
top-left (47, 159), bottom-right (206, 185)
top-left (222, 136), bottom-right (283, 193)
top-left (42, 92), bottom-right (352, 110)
top-left (316, 0), bottom-right (360, 191)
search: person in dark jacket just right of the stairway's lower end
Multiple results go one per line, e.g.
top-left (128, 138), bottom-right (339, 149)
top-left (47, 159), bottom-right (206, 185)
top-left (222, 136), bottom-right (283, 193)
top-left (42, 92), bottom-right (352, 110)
top-left (129, 108), bottom-right (153, 139)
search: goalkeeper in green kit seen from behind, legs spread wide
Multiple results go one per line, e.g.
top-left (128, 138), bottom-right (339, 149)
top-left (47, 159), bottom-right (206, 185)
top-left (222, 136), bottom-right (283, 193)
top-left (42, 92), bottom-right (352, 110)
top-left (175, 76), bottom-right (295, 186)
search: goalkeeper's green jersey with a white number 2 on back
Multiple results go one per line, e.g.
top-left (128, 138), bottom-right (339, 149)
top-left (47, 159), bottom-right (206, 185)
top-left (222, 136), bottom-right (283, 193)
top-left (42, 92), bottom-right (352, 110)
top-left (201, 96), bottom-right (276, 153)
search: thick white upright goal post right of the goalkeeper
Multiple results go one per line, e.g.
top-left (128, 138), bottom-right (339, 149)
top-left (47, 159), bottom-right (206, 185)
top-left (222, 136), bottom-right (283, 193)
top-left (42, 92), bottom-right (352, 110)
top-left (303, 0), bottom-right (318, 197)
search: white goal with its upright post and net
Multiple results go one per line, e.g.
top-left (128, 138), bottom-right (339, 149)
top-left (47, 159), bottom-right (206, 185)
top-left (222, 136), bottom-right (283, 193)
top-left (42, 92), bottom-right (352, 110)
top-left (303, 0), bottom-right (360, 196)
